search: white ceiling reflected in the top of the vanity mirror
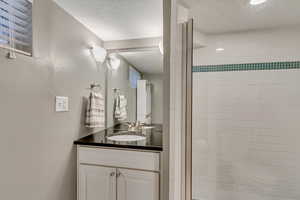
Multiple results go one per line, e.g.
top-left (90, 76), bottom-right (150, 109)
top-left (119, 49), bottom-right (163, 74)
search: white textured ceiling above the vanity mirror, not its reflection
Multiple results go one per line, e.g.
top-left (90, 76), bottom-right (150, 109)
top-left (55, 0), bottom-right (163, 41)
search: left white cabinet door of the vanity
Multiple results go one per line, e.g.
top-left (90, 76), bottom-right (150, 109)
top-left (78, 165), bottom-right (116, 200)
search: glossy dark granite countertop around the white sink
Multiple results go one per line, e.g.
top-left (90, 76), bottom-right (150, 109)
top-left (74, 124), bottom-right (163, 151)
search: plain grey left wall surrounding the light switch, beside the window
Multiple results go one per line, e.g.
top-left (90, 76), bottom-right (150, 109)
top-left (0, 0), bottom-right (104, 200)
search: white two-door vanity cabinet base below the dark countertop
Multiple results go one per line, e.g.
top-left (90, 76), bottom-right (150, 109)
top-left (77, 145), bottom-right (160, 200)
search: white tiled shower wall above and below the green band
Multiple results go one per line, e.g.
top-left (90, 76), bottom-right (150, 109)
top-left (193, 29), bottom-right (300, 200)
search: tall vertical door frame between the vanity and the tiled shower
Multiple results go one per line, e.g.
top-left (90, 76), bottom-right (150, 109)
top-left (161, 0), bottom-right (193, 200)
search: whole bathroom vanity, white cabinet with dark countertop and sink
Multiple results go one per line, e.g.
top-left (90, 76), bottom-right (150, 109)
top-left (74, 125), bottom-right (162, 200)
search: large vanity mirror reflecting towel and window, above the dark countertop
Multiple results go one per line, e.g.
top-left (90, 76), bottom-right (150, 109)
top-left (107, 42), bottom-right (163, 127)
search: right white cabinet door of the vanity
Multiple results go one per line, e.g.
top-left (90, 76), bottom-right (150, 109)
top-left (117, 169), bottom-right (159, 200)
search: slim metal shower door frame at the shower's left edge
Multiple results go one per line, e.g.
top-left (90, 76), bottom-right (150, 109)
top-left (182, 19), bottom-right (193, 200)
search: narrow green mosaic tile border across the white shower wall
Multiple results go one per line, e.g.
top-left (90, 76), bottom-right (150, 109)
top-left (193, 61), bottom-right (300, 72)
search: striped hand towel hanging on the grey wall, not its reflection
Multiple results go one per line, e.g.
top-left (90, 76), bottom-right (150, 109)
top-left (85, 91), bottom-right (105, 128)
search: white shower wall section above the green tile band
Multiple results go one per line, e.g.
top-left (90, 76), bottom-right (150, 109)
top-left (194, 27), bottom-right (300, 66)
